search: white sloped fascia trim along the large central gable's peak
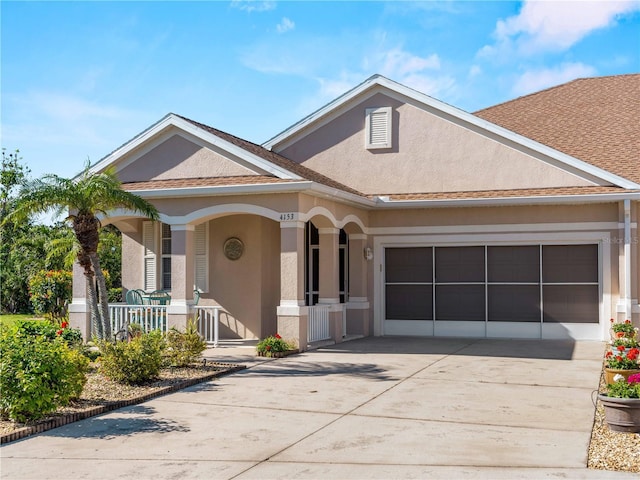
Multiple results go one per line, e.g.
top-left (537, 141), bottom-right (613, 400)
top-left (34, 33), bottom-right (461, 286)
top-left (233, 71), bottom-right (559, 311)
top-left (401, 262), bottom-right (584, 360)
top-left (263, 75), bottom-right (640, 190)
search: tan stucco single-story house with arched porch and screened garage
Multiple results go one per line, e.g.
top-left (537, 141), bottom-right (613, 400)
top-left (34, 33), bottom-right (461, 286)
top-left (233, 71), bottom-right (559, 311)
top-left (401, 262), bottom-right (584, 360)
top-left (71, 75), bottom-right (640, 349)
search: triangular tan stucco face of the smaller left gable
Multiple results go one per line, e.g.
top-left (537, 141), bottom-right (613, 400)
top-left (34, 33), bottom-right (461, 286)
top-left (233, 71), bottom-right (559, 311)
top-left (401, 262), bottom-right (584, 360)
top-left (118, 135), bottom-right (256, 182)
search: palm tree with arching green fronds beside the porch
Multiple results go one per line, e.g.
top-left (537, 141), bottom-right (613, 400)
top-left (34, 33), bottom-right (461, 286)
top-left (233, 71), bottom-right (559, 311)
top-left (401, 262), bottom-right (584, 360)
top-left (8, 163), bottom-right (159, 339)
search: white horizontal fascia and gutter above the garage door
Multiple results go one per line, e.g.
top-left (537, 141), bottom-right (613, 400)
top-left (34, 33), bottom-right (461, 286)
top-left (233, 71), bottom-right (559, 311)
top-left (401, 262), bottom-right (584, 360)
top-left (376, 192), bottom-right (640, 208)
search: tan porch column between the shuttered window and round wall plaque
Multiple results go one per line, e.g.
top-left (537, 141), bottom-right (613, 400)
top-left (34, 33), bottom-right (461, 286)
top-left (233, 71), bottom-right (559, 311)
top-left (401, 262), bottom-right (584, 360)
top-left (167, 225), bottom-right (195, 330)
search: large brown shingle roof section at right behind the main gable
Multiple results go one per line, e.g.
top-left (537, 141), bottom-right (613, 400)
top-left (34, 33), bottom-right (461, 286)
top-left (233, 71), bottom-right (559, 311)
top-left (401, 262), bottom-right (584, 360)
top-left (474, 74), bottom-right (640, 183)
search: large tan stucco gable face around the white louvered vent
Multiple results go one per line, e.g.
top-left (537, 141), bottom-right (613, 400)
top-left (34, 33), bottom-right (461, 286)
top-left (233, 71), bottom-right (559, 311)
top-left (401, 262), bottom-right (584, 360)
top-left (279, 94), bottom-right (592, 194)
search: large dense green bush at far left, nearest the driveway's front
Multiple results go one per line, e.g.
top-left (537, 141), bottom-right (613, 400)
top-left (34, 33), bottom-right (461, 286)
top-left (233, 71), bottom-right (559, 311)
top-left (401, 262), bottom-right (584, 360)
top-left (0, 321), bottom-right (89, 422)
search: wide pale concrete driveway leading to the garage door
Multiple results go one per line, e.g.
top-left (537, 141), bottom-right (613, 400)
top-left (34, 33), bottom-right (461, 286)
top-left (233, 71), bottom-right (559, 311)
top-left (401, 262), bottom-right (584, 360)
top-left (0, 338), bottom-right (634, 480)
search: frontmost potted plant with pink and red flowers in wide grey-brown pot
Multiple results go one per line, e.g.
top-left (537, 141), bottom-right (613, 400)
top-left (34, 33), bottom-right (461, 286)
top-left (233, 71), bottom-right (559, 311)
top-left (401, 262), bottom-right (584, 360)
top-left (598, 373), bottom-right (640, 433)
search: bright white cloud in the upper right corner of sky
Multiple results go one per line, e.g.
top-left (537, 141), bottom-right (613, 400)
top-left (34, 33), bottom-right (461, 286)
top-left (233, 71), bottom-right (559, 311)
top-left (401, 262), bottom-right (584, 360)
top-left (478, 0), bottom-right (640, 56)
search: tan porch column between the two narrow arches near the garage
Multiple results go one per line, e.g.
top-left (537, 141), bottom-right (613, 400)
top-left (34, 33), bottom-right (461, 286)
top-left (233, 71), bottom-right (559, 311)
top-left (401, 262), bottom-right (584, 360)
top-left (318, 227), bottom-right (344, 342)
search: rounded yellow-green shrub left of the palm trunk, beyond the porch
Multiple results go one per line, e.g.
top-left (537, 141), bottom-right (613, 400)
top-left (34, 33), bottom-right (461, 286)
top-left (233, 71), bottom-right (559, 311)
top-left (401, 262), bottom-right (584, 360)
top-left (29, 270), bottom-right (72, 318)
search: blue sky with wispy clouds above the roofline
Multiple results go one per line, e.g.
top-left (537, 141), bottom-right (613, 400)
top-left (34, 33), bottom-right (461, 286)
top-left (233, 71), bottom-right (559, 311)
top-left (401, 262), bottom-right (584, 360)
top-left (0, 0), bottom-right (640, 186)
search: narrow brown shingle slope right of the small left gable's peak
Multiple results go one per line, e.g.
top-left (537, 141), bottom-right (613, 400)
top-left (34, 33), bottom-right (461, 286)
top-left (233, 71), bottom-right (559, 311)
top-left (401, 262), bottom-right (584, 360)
top-left (176, 115), bottom-right (364, 196)
